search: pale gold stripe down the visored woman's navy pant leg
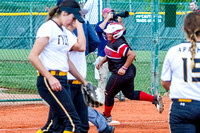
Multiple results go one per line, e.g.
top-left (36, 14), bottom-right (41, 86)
top-left (44, 77), bottom-right (75, 132)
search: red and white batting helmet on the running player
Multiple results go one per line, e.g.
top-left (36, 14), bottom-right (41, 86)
top-left (104, 22), bottom-right (124, 39)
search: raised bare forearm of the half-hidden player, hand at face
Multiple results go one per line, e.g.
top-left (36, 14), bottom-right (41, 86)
top-left (71, 20), bottom-right (86, 52)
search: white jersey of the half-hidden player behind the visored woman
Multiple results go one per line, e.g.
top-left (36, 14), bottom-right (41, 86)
top-left (67, 33), bottom-right (87, 80)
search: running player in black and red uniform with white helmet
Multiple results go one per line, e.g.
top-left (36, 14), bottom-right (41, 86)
top-left (96, 23), bottom-right (163, 122)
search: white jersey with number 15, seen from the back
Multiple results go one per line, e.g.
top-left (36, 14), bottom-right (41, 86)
top-left (161, 43), bottom-right (200, 101)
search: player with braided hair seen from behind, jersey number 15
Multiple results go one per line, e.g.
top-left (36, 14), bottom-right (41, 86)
top-left (161, 12), bottom-right (200, 133)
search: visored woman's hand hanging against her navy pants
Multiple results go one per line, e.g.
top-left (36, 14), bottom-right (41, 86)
top-left (48, 76), bottom-right (62, 92)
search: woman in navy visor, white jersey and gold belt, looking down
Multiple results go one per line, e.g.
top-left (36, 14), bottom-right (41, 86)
top-left (29, 0), bottom-right (87, 133)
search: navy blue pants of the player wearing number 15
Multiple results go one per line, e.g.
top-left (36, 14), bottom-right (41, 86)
top-left (169, 99), bottom-right (200, 133)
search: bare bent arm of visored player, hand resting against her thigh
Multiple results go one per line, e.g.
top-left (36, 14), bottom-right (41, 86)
top-left (28, 37), bottom-right (62, 91)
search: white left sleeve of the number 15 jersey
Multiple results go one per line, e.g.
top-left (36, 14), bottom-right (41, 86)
top-left (161, 50), bottom-right (172, 81)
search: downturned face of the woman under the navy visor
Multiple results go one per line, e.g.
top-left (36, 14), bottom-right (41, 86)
top-left (61, 12), bottom-right (76, 27)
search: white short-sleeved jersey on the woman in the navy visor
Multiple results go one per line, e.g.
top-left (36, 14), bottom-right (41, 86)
top-left (36, 20), bottom-right (74, 72)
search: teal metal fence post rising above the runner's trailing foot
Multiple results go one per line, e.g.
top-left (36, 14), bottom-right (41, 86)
top-left (151, 0), bottom-right (159, 95)
